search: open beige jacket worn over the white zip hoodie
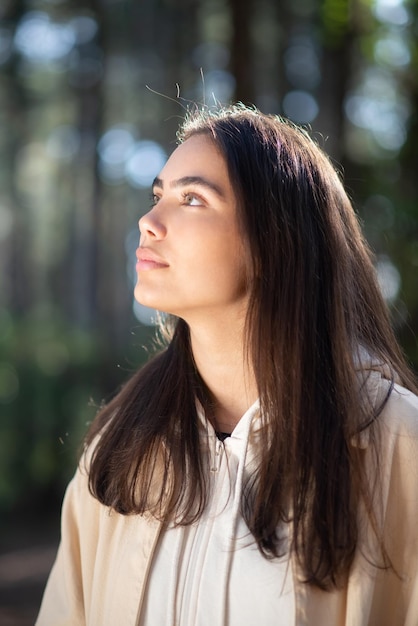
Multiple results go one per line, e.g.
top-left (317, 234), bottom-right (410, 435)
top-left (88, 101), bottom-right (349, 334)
top-left (36, 373), bottom-right (418, 626)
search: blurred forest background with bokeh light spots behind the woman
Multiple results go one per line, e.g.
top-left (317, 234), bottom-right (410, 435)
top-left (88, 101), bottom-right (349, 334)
top-left (0, 0), bottom-right (418, 624)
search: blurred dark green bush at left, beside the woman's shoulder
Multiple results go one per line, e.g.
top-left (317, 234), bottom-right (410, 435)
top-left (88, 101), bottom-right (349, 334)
top-left (0, 311), bottom-right (131, 514)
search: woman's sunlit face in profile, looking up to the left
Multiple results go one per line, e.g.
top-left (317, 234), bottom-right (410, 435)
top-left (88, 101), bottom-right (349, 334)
top-left (135, 135), bottom-right (249, 322)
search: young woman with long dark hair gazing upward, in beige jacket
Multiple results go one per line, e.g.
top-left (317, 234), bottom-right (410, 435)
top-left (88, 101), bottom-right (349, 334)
top-left (37, 106), bottom-right (418, 626)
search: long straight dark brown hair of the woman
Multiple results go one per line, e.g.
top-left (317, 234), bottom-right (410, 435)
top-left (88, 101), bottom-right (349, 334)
top-left (87, 106), bottom-right (415, 588)
